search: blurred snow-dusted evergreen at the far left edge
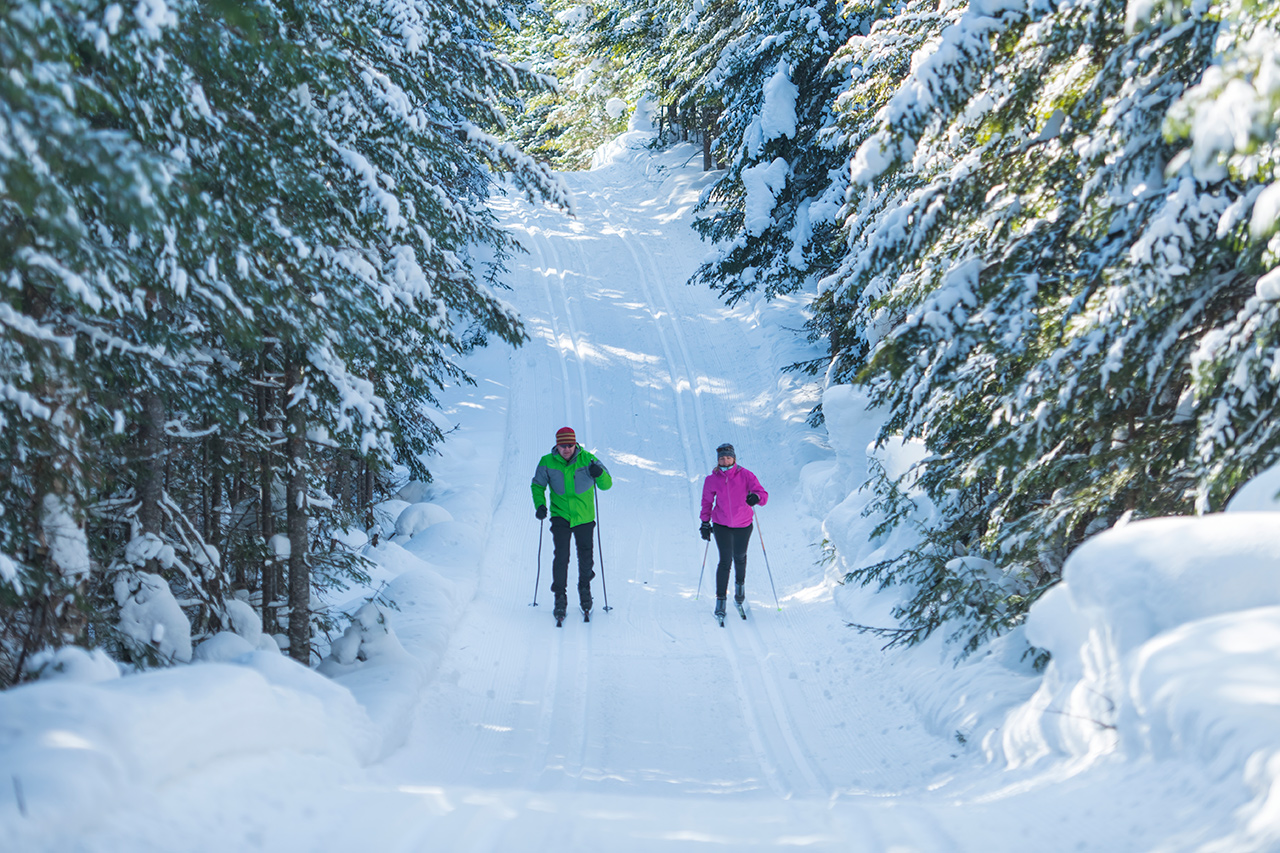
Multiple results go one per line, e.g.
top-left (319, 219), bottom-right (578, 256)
top-left (0, 3), bottom-right (177, 681)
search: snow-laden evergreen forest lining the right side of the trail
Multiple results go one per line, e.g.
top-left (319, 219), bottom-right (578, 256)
top-left (517, 0), bottom-right (1280, 652)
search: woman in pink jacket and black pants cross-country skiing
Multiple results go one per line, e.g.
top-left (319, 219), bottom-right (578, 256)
top-left (700, 444), bottom-right (769, 620)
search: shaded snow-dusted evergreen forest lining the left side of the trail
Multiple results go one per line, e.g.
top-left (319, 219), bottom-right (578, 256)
top-left (0, 0), bottom-right (564, 684)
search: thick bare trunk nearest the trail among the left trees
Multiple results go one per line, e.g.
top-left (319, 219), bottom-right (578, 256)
top-left (284, 347), bottom-right (311, 666)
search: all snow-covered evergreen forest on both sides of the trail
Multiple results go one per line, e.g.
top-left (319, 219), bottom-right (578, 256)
top-left (0, 0), bottom-right (1280, 684)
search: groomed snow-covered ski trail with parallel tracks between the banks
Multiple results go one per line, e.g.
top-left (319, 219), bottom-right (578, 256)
top-left (358, 140), bottom-right (951, 850)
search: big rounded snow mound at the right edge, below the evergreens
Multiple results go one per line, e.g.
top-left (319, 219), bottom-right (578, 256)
top-left (988, 512), bottom-right (1280, 829)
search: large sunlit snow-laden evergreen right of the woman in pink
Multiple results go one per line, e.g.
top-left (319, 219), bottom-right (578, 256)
top-left (818, 1), bottom-right (1266, 649)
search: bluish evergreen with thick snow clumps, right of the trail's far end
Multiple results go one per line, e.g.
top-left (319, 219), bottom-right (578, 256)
top-left (694, 0), bottom-right (861, 305)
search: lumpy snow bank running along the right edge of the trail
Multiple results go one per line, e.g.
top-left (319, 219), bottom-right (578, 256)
top-left (803, 386), bottom-right (1280, 849)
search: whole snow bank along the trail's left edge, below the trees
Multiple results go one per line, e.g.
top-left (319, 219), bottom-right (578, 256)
top-left (0, 397), bottom-right (500, 850)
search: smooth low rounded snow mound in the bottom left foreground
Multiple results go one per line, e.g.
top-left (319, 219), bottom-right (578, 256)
top-left (0, 652), bottom-right (379, 850)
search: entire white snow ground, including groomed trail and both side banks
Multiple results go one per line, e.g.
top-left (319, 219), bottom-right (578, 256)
top-left (0, 131), bottom-right (1280, 853)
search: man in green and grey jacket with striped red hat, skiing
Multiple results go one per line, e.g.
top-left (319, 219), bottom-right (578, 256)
top-left (532, 427), bottom-right (613, 621)
